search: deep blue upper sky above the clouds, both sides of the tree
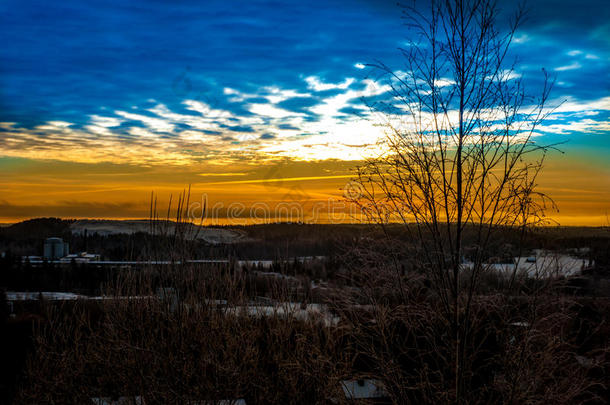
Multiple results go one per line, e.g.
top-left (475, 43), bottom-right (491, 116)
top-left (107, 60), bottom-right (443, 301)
top-left (0, 0), bottom-right (610, 136)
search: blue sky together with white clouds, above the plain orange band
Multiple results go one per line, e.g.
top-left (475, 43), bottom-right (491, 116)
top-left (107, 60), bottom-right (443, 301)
top-left (0, 0), bottom-right (610, 221)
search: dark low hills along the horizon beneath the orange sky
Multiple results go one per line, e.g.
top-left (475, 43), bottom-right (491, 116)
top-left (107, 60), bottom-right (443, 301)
top-left (0, 218), bottom-right (610, 249)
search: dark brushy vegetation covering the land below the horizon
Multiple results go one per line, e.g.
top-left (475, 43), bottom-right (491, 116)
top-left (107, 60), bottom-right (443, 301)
top-left (0, 220), bottom-right (610, 404)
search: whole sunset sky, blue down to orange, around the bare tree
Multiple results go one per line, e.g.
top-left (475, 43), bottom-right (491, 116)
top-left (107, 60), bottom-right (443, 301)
top-left (0, 0), bottom-right (610, 226)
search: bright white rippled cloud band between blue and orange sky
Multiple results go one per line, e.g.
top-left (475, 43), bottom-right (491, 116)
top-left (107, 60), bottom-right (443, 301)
top-left (0, 71), bottom-right (610, 166)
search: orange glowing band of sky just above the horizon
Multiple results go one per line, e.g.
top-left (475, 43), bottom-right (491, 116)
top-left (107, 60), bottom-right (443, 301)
top-left (0, 154), bottom-right (610, 226)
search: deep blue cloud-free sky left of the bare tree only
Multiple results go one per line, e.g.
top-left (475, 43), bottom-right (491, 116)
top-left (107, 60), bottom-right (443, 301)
top-left (0, 0), bottom-right (401, 126)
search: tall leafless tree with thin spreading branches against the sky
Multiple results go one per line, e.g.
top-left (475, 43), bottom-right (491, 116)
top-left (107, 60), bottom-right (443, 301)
top-left (355, 0), bottom-right (553, 402)
